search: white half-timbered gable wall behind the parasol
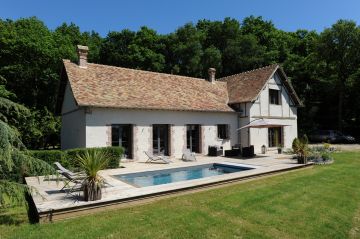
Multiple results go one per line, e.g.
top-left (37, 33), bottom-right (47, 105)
top-left (248, 73), bottom-right (298, 153)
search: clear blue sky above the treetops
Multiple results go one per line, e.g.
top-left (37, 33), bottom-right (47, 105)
top-left (0, 0), bottom-right (360, 36)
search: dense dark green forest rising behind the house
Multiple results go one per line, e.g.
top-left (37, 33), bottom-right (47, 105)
top-left (0, 16), bottom-right (360, 149)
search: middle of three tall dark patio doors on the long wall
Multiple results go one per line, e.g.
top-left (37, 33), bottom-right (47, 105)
top-left (153, 124), bottom-right (169, 156)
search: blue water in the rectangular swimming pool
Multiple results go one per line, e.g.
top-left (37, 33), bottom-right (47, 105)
top-left (114, 163), bottom-right (252, 187)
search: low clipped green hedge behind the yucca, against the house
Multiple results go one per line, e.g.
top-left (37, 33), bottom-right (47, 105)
top-left (29, 147), bottom-right (124, 170)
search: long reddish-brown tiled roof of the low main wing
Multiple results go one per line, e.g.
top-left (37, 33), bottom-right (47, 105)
top-left (64, 60), bottom-right (233, 112)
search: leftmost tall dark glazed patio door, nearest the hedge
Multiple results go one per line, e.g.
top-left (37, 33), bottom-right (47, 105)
top-left (111, 124), bottom-right (133, 159)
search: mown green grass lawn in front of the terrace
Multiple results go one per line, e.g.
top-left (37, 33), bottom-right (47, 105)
top-left (0, 153), bottom-right (360, 239)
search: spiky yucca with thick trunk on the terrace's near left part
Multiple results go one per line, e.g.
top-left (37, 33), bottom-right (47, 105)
top-left (77, 149), bottom-right (109, 201)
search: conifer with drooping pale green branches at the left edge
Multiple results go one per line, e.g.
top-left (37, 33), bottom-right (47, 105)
top-left (0, 80), bottom-right (56, 207)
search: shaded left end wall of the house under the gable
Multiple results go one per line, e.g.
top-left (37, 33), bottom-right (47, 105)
top-left (61, 83), bottom-right (85, 149)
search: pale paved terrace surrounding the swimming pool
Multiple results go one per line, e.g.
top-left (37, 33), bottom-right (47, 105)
top-left (26, 154), bottom-right (310, 221)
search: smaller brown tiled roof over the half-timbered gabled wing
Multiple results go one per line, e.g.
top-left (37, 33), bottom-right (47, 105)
top-left (218, 64), bottom-right (302, 106)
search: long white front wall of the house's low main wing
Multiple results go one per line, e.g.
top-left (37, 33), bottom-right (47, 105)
top-left (86, 108), bottom-right (237, 159)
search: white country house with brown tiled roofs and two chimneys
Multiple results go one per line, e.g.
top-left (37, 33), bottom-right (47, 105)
top-left (57, 46), bottom-right (301, 159)
